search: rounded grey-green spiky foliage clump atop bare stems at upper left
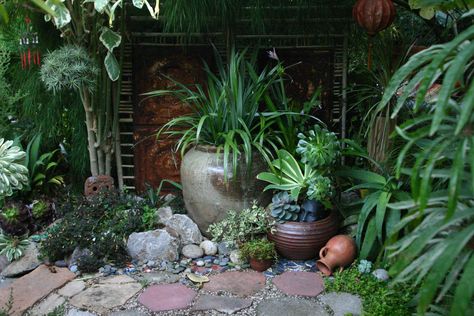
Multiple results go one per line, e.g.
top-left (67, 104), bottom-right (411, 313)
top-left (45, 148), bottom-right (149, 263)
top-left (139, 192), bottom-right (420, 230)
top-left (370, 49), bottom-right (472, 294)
top-left (41, 45), bottom-right (99, 92)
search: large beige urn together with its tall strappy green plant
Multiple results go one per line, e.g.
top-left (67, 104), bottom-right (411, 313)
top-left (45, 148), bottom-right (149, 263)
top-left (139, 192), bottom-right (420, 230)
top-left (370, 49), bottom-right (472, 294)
top-left (146, 50), bottom-right (286, 232)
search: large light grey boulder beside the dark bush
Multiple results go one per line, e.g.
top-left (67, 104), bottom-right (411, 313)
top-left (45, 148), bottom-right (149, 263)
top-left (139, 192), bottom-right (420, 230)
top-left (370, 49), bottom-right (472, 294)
top-left (127, 229), bottom-right (180, 261)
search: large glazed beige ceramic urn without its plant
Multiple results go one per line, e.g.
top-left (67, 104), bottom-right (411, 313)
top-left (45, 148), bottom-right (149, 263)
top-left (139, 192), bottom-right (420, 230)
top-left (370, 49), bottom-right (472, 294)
top-left (181, 146), bottom-right (269, 235)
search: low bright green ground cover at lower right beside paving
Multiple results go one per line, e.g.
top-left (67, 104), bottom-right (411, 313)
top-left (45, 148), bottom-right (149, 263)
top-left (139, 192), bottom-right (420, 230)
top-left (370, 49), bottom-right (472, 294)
top-left (325, 262), bottom-right (416, 316)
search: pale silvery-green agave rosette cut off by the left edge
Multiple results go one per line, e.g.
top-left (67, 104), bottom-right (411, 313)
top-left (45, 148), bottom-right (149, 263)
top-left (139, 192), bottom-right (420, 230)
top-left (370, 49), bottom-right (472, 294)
top-left (0, 138), bottom-right (28, 198)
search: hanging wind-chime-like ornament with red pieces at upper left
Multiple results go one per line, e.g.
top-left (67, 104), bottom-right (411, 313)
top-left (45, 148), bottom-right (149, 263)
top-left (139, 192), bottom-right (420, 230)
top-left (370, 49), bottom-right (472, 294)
top-left (20, 17), bottom-right (41, 69)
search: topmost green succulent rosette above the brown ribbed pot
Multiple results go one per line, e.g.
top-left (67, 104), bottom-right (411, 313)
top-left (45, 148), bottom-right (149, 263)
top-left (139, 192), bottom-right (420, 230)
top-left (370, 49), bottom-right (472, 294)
top-left (296, 125), bottom-right (341, 168)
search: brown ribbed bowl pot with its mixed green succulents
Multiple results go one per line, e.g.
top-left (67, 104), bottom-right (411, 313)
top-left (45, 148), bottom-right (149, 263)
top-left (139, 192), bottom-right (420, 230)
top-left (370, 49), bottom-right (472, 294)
top-left (257, 125), bottom-right (340, 260)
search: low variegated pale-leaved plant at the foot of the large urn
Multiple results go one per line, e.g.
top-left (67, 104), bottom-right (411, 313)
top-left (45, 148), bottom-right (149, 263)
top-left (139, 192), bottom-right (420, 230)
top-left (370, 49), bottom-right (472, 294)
top-left (208, 203), bottom-right (271, 244)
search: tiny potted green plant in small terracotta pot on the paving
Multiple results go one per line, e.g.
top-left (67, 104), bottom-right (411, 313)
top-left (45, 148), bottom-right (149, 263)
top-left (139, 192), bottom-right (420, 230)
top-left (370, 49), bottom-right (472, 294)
top-left (240, 239), bottom-right (277, 272)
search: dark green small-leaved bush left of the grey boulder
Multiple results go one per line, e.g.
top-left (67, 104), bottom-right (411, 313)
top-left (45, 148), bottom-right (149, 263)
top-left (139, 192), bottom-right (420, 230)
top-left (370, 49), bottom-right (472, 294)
top-left (41, 193), bottom-right (161, 269)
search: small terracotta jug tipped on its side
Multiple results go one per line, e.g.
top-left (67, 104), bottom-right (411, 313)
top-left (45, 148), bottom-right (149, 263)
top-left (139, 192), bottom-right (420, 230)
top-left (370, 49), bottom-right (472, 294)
top-left (316, 235), bottom-right (357, 276)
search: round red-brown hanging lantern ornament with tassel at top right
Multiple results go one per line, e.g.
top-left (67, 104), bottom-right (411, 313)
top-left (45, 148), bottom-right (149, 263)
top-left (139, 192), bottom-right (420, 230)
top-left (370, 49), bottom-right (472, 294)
top-left (352, 0), bottom-right (396, 70)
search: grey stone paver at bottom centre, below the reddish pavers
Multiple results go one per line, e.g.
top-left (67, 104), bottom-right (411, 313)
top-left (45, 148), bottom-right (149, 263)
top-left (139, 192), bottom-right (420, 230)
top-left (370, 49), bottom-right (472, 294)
top-left (193, 295), bottom-right (252, 314)
